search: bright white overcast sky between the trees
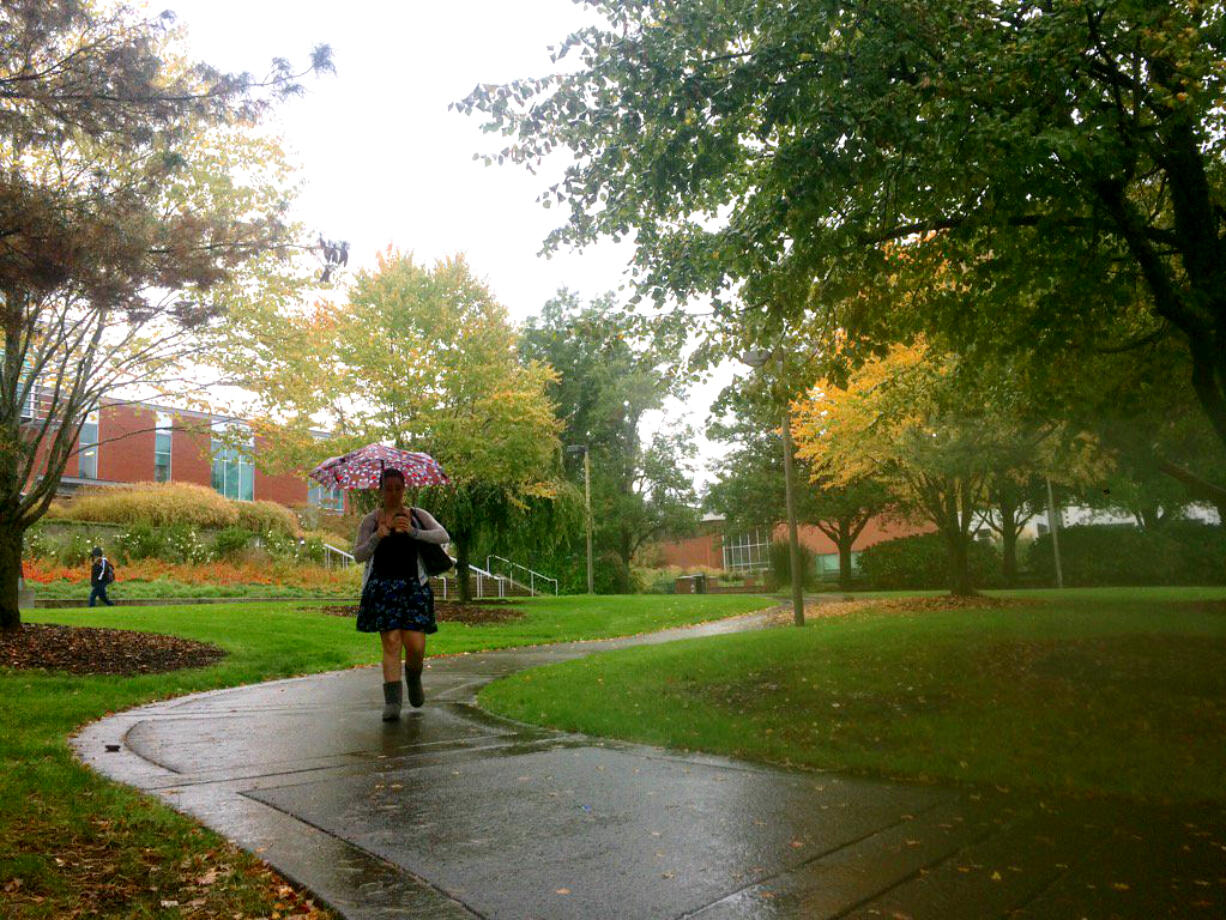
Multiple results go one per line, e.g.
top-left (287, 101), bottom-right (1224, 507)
top-left (166, 0), bottom-right (727, 480)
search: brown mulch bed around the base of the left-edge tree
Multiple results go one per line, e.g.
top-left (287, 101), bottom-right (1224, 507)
top-left (0, 623), bottom-right (226, 677)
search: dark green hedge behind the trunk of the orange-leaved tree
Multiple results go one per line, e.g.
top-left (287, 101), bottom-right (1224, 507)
top-left (859, 534), bottom-right (1003, 590)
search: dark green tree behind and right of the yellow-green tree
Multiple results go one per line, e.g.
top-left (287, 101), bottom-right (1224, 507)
top-left (520, 291), bottom-right (698, 591)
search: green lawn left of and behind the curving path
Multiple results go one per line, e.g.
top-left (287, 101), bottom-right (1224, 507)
top-left (0, 595), bottom-right (769, 919)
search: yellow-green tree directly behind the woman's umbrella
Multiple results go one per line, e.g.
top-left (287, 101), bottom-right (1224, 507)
top-left (229, 248), bottom-right (562, 600)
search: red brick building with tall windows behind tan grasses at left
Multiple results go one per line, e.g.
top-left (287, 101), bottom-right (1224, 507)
top-left (53, 402), bottom-right (343, 510)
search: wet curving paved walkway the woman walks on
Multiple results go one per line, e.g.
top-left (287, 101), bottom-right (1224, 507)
top-left (74, 617), bottom-right (1226, 920)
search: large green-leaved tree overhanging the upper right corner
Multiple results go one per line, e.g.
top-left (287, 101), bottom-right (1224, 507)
top-left (461, 0), bottom-right (1226, 496)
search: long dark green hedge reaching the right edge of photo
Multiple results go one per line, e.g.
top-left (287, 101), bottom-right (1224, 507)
top-left (1027, 521), bottom-right (1226, 586)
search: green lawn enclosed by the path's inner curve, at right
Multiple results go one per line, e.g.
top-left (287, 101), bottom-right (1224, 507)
top-left (481, 589), bottom-right (1226, 801)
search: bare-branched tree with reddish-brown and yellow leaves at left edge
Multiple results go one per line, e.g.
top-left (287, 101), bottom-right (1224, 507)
top-left (0, 0), bottom-right (330, 628)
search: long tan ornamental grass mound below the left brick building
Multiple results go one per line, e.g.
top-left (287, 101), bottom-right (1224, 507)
top-left (48, 482), bottom-right (240, 527)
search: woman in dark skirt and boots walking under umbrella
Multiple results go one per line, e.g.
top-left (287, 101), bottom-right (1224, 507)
top-left (353, 470), bottom-right (451, 721)
